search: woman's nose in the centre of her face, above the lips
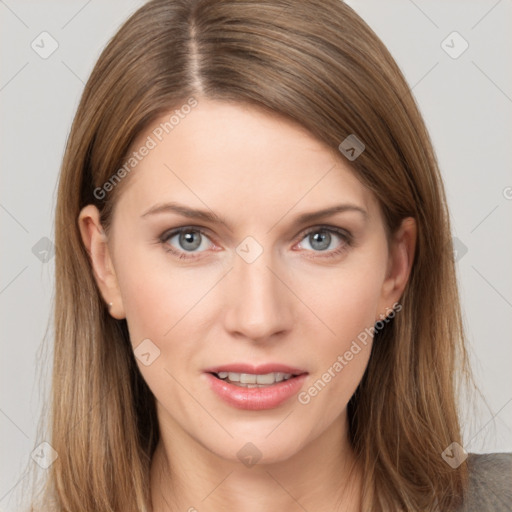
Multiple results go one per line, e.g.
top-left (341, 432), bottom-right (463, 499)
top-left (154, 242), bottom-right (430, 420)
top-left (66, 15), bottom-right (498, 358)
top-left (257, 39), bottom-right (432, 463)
top-left (224, 247), bottom-right (294, 342)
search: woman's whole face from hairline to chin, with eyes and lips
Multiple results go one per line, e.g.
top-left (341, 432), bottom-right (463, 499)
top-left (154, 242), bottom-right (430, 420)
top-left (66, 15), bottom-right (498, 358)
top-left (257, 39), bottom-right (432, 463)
top-left (81, 99), bottom-right (411, 462)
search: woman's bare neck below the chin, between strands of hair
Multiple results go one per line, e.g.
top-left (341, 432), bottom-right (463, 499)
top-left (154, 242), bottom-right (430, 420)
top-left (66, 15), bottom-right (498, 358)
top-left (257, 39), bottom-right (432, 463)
top-left (150, 416), bottom-right (362, 512)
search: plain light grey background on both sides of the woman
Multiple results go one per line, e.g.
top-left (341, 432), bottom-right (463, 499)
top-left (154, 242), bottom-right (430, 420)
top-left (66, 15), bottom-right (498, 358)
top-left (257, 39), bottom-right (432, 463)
top-left (0, 0), bottom-right (512, 511)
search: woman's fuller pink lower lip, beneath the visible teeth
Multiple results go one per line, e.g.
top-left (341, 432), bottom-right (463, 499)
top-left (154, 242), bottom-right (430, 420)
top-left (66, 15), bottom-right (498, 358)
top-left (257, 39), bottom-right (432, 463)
top-left (205, 373), bottom-right (308, 411)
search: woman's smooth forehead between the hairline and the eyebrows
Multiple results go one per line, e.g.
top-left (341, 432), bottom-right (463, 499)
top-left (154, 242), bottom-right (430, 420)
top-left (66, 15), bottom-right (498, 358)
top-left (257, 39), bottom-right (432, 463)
top-left (114, 99), bottom-right (374, 219)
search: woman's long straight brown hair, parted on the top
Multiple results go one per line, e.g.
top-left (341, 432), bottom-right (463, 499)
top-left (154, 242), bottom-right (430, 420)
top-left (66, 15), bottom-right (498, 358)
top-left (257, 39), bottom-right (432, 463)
top-left (27, 0), bottom-right (469, 512)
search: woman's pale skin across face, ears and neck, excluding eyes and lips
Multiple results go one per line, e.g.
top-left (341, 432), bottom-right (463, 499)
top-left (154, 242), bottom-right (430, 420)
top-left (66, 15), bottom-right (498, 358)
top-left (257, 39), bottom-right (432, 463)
top-left (79, 98), bottom-right (416, 512)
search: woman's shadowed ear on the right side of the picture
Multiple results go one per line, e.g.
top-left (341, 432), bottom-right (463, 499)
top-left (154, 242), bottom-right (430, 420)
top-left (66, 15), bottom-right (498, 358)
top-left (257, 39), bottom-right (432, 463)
top-left (376, 217), bottom-right (417, 321)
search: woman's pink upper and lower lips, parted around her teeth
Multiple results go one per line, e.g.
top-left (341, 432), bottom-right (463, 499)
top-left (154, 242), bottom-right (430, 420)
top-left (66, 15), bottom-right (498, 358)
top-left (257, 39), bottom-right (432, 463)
top-left (204, 363), bottom-right (308, 411)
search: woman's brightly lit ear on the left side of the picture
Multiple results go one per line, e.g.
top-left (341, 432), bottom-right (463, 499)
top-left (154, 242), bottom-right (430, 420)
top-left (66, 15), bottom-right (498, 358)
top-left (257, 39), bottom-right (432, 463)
top-left (78, 204), bottom-right (125, 320)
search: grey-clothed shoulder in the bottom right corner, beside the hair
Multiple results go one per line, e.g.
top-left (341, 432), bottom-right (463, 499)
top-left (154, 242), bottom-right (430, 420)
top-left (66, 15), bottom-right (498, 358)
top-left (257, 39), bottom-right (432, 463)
top-left (460, 453), bottom-right (512, 512)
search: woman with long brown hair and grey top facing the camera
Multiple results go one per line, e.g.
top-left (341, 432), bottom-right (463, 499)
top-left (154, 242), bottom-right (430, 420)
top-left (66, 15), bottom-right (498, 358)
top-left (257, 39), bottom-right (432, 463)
top-left (28, 0), bottom-right (511, 512)
